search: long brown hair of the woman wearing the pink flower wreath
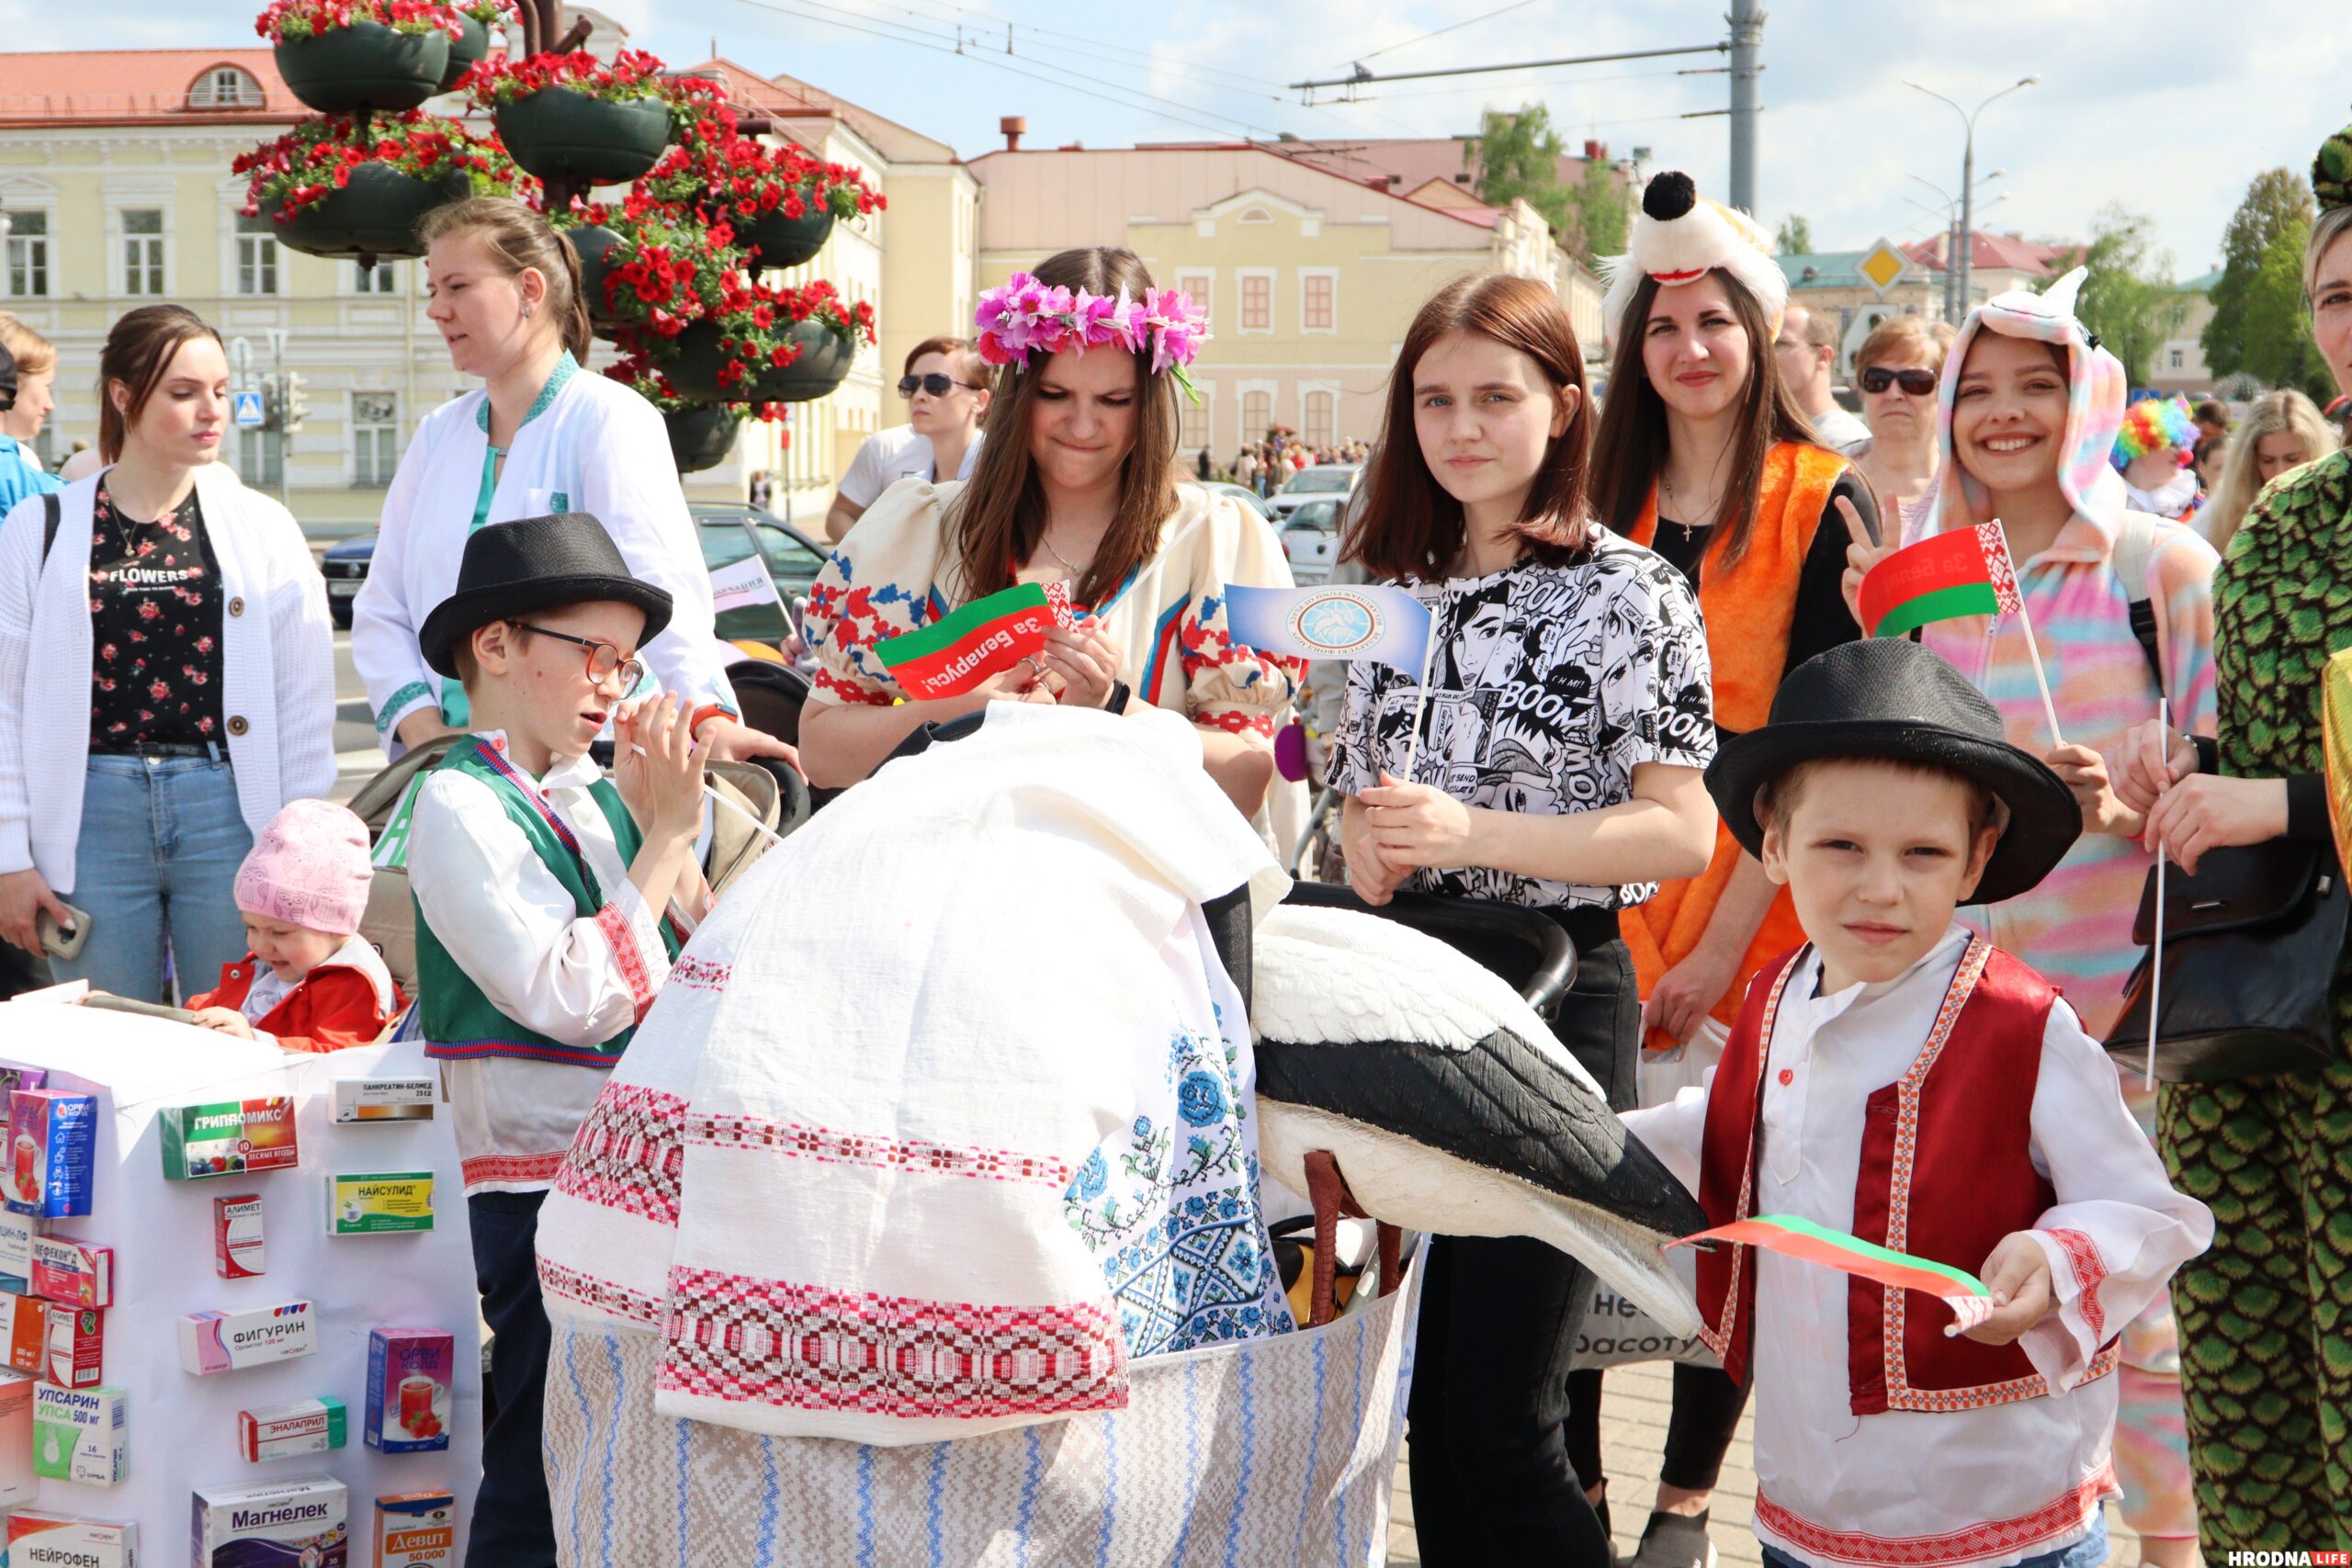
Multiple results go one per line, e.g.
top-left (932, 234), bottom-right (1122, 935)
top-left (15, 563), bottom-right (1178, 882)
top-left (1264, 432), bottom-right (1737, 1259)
top-left (948, 247), bottom-right (1179, 606)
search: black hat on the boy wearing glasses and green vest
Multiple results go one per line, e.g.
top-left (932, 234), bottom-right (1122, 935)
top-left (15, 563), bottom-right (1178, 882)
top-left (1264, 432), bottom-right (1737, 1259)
top-left (416, 513), bottom-right (671, 680)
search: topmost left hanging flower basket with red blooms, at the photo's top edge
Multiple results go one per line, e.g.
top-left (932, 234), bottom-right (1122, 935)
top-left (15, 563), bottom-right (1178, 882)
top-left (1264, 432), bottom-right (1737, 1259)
top-left (254, 0), bottom-right (463, 115)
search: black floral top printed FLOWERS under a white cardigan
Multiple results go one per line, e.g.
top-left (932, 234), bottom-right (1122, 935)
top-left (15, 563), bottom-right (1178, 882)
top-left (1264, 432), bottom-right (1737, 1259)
top-left (89, 482), bottom-right (221, 750)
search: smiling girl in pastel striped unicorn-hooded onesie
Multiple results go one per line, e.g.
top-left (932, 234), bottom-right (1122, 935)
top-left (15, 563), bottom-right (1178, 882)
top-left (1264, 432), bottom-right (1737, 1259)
top-left (1847, 268), bottom-right (2216, 1568)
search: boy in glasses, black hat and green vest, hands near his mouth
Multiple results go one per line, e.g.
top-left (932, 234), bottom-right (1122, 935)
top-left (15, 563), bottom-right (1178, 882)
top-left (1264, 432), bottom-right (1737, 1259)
top-left (407, 513), bottom-right (708, 1568)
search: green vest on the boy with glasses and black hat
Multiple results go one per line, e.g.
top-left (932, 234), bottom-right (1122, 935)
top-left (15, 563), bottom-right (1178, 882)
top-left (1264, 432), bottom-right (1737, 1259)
top-left (409, 740), bottom-right (677, 1067)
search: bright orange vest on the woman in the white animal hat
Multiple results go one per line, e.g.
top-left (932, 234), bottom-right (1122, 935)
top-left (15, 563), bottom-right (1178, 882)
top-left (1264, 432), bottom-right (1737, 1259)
top-left (1618, 442), bottom-right (1849, 1051)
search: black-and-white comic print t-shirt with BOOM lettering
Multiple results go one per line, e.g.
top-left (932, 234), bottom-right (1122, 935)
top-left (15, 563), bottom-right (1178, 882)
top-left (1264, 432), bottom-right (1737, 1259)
top-left (1329, 534), bottom-right (1714, 909)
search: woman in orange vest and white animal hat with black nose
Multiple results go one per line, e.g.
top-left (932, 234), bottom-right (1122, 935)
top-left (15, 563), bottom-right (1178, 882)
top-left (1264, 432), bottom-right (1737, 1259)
top-left (1569, 174), bottom-right (1877, 1568)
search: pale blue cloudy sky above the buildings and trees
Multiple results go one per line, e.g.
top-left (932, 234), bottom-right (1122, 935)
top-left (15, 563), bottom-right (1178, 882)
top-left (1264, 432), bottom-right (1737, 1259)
top-left (55, 0), bottom-right (2352, 277)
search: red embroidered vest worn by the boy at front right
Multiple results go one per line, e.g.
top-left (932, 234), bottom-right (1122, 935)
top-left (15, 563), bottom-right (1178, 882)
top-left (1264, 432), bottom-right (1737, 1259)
top-left (1698, 938), bottom-right (2114, 1416)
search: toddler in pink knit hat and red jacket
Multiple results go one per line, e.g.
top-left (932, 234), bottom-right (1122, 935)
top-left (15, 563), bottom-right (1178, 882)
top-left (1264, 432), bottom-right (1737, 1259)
top-left (188, 799), bottom-right (404, 1051)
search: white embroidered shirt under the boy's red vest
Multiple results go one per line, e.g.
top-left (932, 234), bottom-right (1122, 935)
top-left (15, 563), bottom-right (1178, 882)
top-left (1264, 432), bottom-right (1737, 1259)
top-left (1625, 926), bottom-right (2213, 1568)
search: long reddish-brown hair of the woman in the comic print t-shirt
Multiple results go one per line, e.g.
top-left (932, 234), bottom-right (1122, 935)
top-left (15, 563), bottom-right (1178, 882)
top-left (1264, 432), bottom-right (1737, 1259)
top-left (1343, 273), bottom-right (1592, 579)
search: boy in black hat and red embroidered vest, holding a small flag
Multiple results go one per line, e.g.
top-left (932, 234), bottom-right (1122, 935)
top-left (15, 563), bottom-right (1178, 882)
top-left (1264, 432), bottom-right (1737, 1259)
top-left (1625, 639), bottom-right (2213, 1568)
